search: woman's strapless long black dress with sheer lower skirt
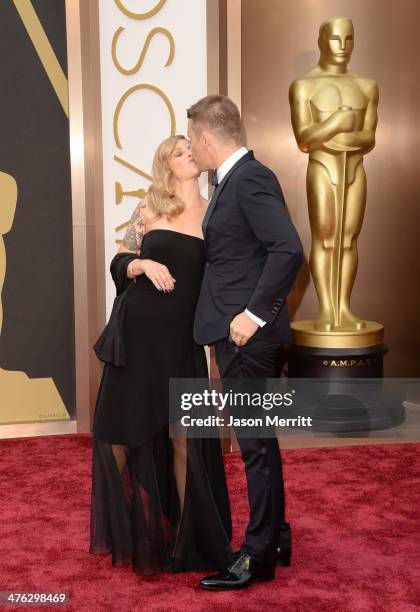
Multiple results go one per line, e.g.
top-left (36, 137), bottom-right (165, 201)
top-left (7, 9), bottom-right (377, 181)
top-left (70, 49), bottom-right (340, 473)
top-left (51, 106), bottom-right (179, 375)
top-left (90, 229), bottom-right (231, 574)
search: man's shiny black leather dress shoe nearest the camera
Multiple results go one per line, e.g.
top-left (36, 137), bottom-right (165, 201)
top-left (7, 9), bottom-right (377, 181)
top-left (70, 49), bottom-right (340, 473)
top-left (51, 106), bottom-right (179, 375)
top-left (200, 552), bottom-right (275, 591)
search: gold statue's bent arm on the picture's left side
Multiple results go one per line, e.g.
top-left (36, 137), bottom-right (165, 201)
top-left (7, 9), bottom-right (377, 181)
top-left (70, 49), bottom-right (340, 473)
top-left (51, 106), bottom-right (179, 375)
top-left (289, 81), bottom-right (355, 153)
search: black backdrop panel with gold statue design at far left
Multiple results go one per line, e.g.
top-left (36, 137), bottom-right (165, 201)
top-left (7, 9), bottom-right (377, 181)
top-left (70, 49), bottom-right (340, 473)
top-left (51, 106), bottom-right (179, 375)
top-left (0, 0), bottom-right (75, 424)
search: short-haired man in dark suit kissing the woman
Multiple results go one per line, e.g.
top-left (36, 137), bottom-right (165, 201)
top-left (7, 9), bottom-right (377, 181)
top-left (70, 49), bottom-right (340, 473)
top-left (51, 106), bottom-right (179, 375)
top-left (187, 95), bottom-right (302, 590)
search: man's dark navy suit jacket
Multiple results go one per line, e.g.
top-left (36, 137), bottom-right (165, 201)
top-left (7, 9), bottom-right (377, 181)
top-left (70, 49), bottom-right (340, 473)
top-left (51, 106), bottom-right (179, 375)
top-left (194, 151), bottom-right (302, 344)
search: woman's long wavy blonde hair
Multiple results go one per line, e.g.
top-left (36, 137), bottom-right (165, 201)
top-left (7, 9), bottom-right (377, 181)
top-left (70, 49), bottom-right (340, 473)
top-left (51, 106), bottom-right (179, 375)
top-left (147, 134), bottom-right (185, 219)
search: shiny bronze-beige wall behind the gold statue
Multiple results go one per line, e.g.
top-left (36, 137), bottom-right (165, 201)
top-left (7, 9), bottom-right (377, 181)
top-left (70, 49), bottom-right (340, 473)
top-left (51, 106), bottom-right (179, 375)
top-left (242, 0), bottom-right (420, 376)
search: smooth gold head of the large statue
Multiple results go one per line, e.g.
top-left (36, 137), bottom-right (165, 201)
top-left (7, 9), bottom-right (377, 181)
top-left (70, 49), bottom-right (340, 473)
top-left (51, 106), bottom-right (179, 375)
top-left (318, 17), bottom-right (354, 66)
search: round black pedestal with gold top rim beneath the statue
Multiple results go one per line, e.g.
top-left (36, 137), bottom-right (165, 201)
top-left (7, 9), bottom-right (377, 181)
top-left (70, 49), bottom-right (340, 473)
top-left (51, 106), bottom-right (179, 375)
top-left (288, 321), bottom-right (405, 433)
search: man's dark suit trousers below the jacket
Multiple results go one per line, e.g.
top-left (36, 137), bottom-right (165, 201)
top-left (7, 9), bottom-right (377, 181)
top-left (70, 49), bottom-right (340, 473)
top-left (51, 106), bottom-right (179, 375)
top-left (215, 325), bottom-right (291, 563)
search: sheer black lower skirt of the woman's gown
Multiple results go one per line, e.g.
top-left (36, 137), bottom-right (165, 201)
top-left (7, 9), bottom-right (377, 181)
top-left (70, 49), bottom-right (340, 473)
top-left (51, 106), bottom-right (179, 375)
top-left (90, 428), bottom-right (231, 575)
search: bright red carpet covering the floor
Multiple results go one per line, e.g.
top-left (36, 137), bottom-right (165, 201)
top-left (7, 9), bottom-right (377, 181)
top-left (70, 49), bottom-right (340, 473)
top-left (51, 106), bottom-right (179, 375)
top-left (0, 434), bottom-right (420, 612)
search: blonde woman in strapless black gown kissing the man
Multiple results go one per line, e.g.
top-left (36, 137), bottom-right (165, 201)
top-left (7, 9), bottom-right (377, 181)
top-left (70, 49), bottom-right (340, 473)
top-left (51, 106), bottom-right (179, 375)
top-left (90, 136), bottom-right (231, 574)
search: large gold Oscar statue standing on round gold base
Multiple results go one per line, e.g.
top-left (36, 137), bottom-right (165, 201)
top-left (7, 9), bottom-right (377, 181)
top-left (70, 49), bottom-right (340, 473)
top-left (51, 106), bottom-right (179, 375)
top-left (289, 17), bottom-right (384, 348)
